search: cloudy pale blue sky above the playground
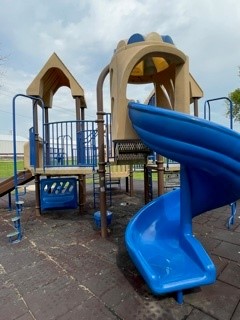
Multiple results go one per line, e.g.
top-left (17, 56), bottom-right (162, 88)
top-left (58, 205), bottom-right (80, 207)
top-left (0, 0), bottom-right (240, 136)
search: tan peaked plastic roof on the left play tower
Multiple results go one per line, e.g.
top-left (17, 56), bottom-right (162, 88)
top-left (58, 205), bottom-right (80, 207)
top-left (26, 52), bottom-right (86, 108)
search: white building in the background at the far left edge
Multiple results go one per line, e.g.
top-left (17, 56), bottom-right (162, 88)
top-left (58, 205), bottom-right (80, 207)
top-left (0, 134), bottom-right (28, 158)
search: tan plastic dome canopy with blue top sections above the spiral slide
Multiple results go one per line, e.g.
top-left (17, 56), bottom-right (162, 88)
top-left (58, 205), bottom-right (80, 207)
top-left (109, 32), bottom-right (203, 141)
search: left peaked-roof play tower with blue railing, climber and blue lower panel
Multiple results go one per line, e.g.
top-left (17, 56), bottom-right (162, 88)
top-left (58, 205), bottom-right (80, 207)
top-left (0, 53), bottom-right (133, 242)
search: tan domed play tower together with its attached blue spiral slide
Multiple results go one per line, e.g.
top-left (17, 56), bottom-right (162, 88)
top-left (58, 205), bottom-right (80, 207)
top-left (94, 33), bottom-right (240, 303)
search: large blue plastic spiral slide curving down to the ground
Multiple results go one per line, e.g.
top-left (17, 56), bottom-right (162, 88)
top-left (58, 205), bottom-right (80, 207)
top-left (125, 102), bottom-right (240, 303)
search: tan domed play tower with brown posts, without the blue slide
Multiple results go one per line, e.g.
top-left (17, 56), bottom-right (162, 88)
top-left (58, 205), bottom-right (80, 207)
top-left (97, 32), bottom-right (203, 237)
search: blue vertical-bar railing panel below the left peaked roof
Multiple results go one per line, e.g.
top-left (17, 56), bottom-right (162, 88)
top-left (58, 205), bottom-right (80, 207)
top-left (43, 120), bottom-right (97, 168)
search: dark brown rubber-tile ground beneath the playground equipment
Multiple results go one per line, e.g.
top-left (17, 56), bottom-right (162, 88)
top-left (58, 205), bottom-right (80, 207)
top-left (0, 182), bottom-right (240, 320)
